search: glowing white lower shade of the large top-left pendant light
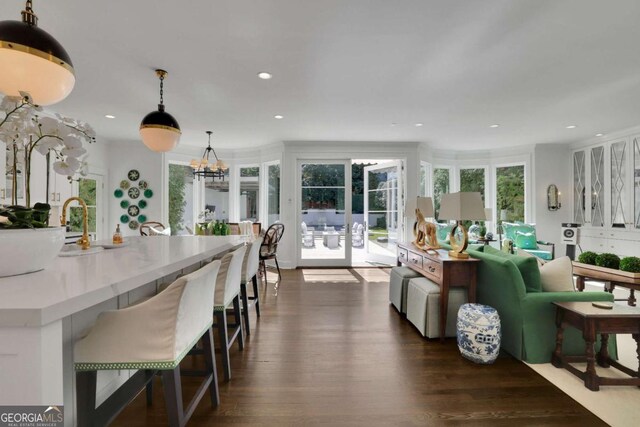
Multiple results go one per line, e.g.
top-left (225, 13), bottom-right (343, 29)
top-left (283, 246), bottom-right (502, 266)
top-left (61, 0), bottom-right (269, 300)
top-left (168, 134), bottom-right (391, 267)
top-left (0, 49), bottom-right (76, 105)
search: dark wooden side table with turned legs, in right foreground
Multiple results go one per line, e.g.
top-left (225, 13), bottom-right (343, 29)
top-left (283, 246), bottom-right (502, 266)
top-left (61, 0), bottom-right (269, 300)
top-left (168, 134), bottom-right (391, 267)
top-left (551, 302), bottom-right (640, 391)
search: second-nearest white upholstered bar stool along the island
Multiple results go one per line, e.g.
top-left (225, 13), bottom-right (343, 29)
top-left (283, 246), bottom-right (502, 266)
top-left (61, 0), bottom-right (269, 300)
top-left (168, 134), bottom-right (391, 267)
top-left (213, 246), bottom-right (247, 381)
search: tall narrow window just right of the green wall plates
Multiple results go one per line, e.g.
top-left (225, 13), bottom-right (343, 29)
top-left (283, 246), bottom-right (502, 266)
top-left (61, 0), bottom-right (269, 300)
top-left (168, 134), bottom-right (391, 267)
top-left (169, 164), bottom-right (194, 235)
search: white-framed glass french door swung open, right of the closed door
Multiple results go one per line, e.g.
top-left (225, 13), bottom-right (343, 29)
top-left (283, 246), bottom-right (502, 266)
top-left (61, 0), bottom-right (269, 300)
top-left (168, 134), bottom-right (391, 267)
top-left (363, 160), bottom-right (404, 265)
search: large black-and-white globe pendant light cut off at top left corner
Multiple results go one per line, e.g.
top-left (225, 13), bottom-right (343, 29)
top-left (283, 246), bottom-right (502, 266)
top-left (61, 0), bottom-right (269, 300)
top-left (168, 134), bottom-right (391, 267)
top-left (0, 0), bottom-right (76, 105)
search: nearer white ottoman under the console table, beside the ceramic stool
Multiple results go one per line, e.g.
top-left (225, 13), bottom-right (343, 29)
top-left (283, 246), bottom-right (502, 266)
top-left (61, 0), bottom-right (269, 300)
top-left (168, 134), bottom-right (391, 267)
top-left (407, 277), bottom-right (467, 338)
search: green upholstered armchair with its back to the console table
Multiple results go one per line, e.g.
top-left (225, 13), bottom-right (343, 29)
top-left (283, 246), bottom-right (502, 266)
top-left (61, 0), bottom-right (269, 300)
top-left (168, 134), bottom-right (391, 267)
top-left (467, 246), bottom-right (617, 363)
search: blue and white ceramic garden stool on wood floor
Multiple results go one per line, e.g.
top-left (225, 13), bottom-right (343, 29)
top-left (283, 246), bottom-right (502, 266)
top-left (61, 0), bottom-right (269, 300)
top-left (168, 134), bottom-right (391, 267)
top-left (457, 304), bottom-right (500, 364)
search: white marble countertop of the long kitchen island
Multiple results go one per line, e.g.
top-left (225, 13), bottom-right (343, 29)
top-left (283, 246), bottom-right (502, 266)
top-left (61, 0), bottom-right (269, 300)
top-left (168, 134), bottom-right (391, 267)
top-left (0, 236), bottom-right (244, 327)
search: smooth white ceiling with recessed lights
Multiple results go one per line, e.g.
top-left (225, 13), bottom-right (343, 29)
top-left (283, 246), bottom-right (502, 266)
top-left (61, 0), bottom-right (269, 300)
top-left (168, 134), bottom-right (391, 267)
top-left (0, 0), bottom-right (640, 150)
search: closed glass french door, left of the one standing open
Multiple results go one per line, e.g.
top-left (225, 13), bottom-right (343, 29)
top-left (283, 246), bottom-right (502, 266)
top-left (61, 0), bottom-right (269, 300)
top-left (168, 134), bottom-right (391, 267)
top-left (296, 159), bottom-right (351, 267)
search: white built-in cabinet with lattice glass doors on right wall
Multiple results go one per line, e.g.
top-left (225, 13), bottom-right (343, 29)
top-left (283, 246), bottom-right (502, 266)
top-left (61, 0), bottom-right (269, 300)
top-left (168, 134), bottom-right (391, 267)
top-left (573, 139), bottom-right (640, 255)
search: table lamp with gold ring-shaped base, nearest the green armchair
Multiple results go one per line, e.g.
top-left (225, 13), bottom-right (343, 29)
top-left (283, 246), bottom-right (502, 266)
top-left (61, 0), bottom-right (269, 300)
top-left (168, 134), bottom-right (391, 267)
top-left (438, 192), bottom-right (486, 259)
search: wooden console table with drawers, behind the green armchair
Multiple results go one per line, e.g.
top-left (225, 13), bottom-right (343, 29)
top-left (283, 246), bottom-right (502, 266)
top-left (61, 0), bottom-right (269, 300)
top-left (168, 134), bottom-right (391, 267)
top-left (398, 243), bottom-right (480, 341)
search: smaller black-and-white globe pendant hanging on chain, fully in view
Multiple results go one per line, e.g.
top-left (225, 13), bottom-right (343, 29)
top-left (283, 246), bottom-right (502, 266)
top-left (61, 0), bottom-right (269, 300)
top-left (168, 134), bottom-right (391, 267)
top-left (140, 70), bottom-right (182, 153)
